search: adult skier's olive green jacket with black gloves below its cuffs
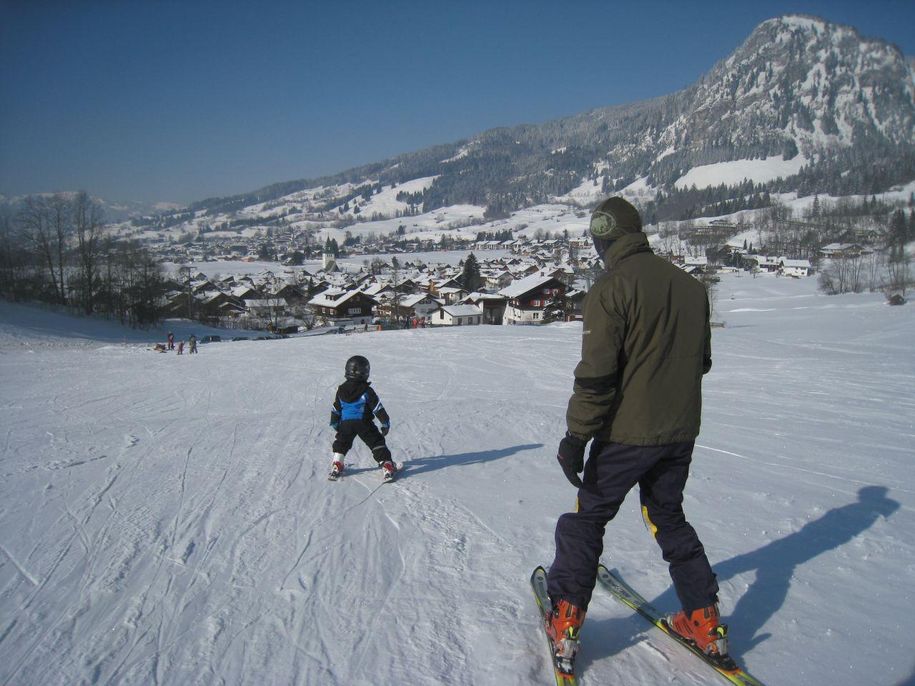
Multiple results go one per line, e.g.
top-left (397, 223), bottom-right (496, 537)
top-left (566, 231), bottom-right (712, 445)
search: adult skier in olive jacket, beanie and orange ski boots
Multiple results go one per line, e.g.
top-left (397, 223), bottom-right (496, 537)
top-left (547, 197), bottom-right (728, 659)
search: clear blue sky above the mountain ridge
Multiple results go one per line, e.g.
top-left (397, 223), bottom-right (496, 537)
top-left (0, 0), bottom-right (915, 203)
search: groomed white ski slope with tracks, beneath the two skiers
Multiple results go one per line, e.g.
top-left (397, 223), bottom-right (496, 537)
top-left (0, 275), bottom-right (915, 686)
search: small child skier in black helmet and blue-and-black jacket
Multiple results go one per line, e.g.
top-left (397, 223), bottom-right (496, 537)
top-left (329, 355), bottom-right (397, 481)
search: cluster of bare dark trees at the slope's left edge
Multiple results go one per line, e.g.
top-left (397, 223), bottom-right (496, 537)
top-left (0, 192), bottom-right (166, 326)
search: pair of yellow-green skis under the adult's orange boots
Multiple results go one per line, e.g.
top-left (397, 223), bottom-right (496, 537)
top-left (531, 564), bottom-right (763, 686)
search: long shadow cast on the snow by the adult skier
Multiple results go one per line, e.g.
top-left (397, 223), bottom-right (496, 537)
top-left (583, 486), bottom-right (900, 672)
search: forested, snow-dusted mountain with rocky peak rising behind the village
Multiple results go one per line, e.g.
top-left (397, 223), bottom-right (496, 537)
top-left (154, 15), bottom-right (915, 232)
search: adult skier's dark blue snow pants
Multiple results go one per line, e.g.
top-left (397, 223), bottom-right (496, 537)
top-left (548, 441), bottom-right (718, 611)
